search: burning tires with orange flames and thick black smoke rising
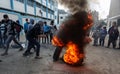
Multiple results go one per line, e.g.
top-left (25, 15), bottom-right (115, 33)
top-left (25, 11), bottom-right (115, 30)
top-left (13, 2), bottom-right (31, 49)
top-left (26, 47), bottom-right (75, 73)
top-left (52, 0), bottom-right (92, 65)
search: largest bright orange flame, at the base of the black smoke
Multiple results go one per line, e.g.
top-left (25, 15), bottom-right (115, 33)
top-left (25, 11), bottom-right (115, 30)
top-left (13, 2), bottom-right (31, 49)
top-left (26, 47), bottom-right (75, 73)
top-left (63, 42), bottom-right (84, 65)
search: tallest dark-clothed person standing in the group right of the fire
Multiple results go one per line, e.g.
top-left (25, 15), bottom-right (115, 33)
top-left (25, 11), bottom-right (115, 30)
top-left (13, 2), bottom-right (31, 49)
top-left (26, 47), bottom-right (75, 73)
top-left (107, 22), bottom-right (119, 48)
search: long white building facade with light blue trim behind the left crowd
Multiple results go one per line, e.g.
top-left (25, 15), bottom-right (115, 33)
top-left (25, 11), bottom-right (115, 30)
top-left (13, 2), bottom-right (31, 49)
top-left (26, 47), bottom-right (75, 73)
top-left (0, 0), bottom-right (58, 25)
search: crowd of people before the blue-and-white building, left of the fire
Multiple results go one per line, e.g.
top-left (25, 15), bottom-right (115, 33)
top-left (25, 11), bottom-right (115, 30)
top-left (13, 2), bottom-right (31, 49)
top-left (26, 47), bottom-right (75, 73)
top-left (0, 14), bottom-right (57, 61)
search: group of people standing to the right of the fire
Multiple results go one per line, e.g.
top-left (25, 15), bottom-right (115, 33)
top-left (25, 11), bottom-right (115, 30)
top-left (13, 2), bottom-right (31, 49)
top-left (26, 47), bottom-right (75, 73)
top-left (92, 22), bottom-right (120, 49)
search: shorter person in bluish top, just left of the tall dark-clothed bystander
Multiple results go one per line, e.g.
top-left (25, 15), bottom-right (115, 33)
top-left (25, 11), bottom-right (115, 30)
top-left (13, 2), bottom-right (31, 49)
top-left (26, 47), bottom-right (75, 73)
top-left (99, 27), bottom-right (107, 46)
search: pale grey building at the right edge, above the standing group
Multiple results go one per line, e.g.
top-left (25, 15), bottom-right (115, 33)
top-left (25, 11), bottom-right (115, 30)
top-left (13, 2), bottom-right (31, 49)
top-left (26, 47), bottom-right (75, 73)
top-left (107, 0), bottom-right (120, 27)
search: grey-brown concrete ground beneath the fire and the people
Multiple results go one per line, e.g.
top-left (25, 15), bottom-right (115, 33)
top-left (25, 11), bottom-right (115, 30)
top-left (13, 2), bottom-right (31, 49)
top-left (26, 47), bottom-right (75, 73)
top-left (0, 44), bottom-right (120, 74)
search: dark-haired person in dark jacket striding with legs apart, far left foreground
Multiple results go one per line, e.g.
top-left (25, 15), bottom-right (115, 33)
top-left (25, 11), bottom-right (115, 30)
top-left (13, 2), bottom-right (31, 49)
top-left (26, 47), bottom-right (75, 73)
top-left (1, 14), bottom-right (23, 56)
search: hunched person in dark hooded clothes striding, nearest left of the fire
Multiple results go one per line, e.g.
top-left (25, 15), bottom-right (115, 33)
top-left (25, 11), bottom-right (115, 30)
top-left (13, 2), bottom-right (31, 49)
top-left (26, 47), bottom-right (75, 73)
top-left (23, 21), bottom-right (43, 59)
